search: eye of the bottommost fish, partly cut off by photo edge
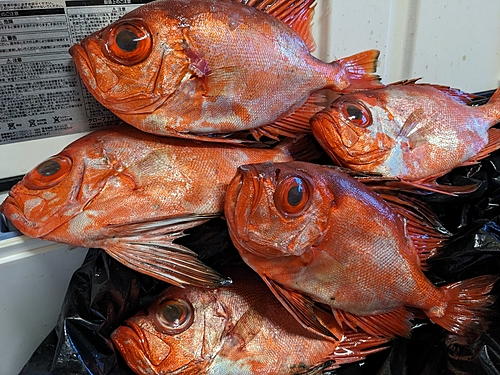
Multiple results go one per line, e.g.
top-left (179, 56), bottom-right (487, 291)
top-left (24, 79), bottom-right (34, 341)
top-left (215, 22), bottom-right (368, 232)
top-left (154, 299), bottom-right (194, 334)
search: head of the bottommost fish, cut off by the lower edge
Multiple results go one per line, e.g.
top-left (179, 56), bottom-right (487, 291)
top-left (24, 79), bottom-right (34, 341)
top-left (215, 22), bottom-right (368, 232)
top-left (111, 286), bottom-right (231, 375)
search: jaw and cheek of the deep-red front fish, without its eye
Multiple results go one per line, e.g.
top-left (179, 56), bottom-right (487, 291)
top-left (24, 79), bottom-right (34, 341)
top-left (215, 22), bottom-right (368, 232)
top-left (225, 162), bottom-right (328, 263)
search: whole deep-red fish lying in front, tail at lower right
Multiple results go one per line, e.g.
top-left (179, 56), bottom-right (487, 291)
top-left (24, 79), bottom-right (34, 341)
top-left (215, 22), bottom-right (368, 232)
top-left (225, 162), bottom-right (498, 337)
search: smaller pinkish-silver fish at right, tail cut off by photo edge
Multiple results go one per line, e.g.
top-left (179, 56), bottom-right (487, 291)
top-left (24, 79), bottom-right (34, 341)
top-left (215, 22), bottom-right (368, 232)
top-left (311, 80), bottom-right (500, 193)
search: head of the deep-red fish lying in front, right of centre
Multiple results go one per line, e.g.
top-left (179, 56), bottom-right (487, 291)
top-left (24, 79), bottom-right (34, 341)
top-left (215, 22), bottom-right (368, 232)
top-left (225, 162), bottom-right (332, 258)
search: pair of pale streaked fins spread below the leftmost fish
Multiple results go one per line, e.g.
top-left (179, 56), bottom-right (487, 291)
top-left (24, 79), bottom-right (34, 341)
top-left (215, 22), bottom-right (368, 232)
top-left (102, 215), bottom-right (231, 288)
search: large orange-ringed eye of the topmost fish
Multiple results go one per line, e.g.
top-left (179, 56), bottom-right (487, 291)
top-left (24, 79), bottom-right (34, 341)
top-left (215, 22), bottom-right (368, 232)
top-left (103, 21), bottom-right (153, 66)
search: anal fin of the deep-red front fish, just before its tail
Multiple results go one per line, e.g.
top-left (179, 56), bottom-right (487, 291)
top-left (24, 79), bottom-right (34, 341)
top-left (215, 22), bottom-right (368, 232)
top-left (332, 307), bottom-right (413, 338)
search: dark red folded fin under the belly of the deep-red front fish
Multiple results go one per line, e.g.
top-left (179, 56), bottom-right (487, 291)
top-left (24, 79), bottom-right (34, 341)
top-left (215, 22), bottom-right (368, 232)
top-left (262, 276), bottom-right (343, 340)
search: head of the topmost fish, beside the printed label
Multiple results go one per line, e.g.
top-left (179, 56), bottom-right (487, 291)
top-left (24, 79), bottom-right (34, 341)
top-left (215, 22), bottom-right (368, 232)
top-left (69, 2), bottom-right (190, 117)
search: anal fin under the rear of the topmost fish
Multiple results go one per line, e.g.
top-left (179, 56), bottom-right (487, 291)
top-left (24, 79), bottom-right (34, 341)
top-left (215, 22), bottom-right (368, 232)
top-left (250, 93), bottom-right (326, 139)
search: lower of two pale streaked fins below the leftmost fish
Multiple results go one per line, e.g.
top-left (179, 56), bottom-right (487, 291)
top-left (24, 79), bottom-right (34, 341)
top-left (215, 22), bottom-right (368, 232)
top-left (104, 241), bottom-right (232, 288)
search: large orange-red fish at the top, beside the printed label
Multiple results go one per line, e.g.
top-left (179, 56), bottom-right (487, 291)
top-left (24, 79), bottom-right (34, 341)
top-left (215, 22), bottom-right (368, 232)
top-left (70, 0), bottom-right (379, 140)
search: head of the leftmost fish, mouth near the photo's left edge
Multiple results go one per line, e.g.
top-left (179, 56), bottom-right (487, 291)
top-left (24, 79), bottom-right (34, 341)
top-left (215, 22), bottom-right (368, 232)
top-left (0, 132), bottom-right (131, 242)
